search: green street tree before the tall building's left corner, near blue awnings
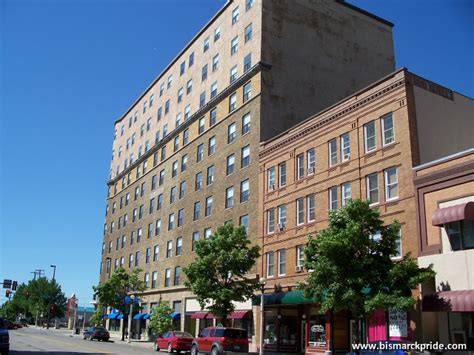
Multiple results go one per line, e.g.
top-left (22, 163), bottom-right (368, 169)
top-left (92, 267), bottom-right (146, 340)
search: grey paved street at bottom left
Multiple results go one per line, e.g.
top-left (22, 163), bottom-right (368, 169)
top-left (10, 327), bottom-right (159, 355)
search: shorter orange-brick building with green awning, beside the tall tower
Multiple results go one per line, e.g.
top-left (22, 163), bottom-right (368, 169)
top-left (258, 69), bottom-right (474, 352)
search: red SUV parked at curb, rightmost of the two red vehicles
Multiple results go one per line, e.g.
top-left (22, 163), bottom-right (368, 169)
top-left (191, 327), bottom-right (249, 355)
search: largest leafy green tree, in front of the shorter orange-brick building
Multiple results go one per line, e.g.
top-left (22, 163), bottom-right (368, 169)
top-left (300, 200), bottom-right (434, 336)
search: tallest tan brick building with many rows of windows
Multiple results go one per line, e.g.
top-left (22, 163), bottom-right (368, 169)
top-left (100, 0), bottom-right (394, 346)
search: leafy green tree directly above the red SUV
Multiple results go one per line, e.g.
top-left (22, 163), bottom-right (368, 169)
top-left (183, 224), bottom-right (260, 324)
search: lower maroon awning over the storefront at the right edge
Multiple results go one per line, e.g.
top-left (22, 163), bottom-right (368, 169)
top-left (422, 290), bottom-right (474, 312)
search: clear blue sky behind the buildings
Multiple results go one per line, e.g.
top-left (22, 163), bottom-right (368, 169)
top-left (0, 0), bottom-right (474, 304)
